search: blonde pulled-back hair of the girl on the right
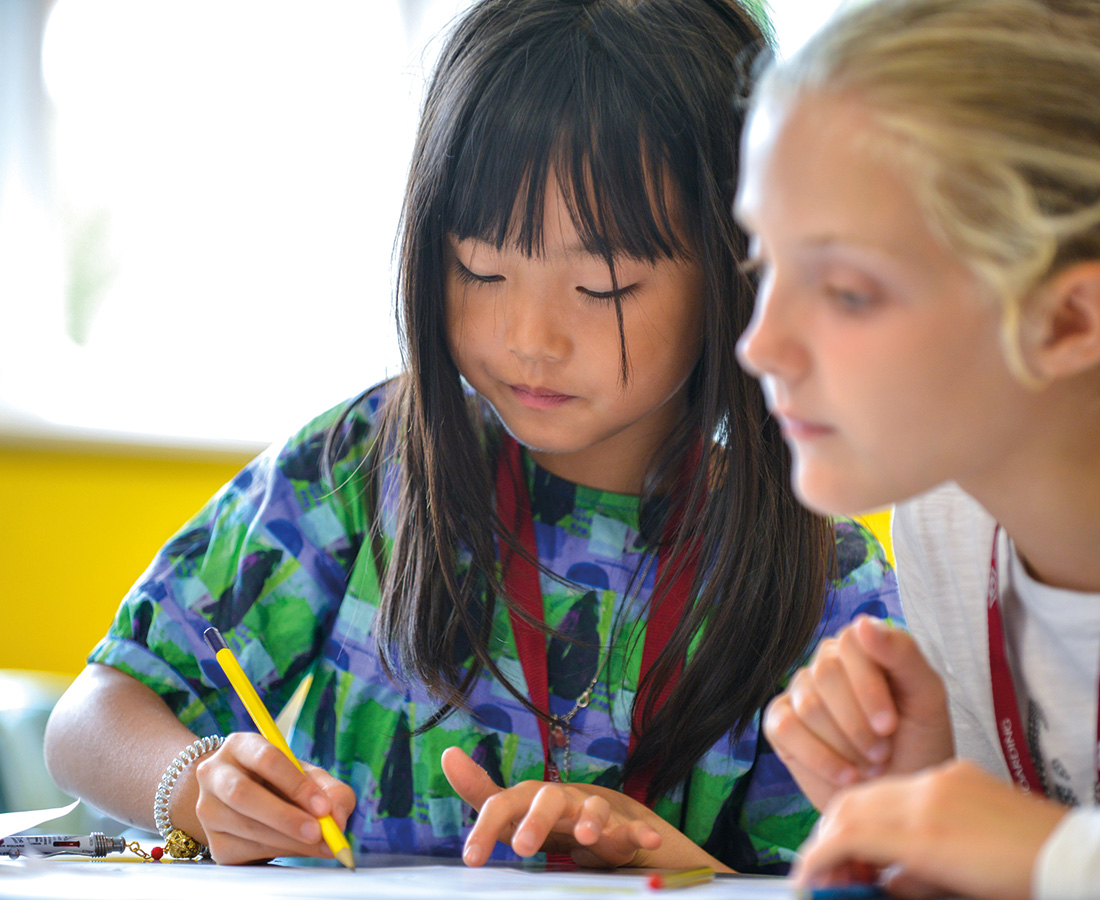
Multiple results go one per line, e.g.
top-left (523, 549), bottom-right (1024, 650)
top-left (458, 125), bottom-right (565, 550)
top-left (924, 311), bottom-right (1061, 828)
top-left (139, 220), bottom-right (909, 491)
top-left (754, 0), bottom-right (1100, 380)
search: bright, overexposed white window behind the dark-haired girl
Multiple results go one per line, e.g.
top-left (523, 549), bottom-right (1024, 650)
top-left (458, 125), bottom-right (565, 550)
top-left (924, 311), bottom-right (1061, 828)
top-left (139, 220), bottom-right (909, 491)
top-left (0, 0), bottom-right (831, 442)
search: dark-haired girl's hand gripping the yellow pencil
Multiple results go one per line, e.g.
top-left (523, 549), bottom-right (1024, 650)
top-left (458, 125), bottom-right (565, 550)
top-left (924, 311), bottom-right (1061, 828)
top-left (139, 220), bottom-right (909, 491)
top-left (194, 734), bottom-right (355, 864)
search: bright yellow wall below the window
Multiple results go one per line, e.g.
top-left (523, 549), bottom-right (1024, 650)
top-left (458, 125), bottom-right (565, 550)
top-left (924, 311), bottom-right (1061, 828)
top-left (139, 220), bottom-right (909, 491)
top-left (0, 447), bottom-right (889, 674)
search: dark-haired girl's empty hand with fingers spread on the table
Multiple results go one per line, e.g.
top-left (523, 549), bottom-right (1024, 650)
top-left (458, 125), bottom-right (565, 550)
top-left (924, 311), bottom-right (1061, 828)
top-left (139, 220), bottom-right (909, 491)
top-left (442, 747), bottom-right (727, 870)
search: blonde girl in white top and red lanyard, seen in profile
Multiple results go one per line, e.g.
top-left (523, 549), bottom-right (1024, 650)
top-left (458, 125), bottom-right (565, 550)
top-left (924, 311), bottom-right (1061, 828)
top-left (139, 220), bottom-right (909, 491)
top-left (736, 0), bottom-right (1100, 900)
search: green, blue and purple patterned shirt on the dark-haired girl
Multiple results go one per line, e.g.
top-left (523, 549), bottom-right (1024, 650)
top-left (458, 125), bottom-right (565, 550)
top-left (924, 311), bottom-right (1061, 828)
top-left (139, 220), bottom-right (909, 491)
top-left (89, 380), bottom-right (900, 871)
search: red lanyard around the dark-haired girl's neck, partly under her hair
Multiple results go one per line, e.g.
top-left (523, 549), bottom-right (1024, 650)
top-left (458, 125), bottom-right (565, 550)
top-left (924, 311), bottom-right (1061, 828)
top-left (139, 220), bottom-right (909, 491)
top-left (496, 435), bottom-right (697, 803)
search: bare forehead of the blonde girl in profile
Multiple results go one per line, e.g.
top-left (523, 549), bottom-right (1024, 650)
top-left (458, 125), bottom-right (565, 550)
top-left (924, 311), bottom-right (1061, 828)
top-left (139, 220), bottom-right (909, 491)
top-left (735, 94), bottom-right (979, 305)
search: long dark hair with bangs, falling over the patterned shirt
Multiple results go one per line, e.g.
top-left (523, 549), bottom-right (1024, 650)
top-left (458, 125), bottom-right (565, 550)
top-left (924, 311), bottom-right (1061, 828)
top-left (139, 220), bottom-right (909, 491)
top-left (356, 0), bottom-right (832, 795)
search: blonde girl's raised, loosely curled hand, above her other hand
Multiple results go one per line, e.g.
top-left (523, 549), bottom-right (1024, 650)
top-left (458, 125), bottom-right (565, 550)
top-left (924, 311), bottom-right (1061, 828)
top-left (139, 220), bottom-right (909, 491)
top-left (763, 616), bottom-right (954, 809)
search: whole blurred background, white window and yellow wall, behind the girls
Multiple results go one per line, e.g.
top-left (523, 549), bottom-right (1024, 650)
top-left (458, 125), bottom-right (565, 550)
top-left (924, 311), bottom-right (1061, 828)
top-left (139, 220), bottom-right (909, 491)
top-left (0, 0), bottom-right (866, 827)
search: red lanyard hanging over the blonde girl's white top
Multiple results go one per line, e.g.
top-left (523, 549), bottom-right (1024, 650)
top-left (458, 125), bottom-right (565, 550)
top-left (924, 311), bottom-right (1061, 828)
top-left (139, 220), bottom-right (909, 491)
top-left (987, 525), bottom-right (1100, 794)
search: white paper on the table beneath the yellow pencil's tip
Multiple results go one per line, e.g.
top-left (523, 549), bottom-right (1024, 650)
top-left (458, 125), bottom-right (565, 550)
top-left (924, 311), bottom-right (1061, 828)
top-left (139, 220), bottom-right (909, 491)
top-left (0, 859), bottom-right (798, 900)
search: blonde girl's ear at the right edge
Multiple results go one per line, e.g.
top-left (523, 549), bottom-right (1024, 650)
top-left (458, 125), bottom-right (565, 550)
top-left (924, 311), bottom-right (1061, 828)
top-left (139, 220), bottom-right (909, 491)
top-left (1021, 260), bottom-right (1100, 381)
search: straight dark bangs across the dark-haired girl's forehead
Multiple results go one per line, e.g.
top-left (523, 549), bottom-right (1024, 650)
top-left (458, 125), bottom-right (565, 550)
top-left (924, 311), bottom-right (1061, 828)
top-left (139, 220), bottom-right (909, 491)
top-left (442, 42), bottom-right (695, 262)
